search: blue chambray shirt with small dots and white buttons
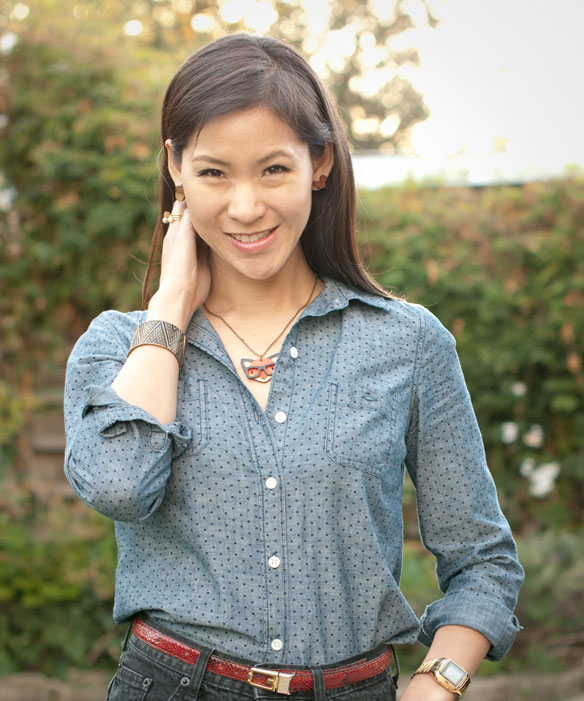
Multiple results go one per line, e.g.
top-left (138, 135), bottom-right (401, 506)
top-left (65, 279), bottom-right (523, 665)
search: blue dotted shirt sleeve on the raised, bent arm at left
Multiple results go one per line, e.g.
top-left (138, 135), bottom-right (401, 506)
top-left (65, 311), bottom-right (191, 521)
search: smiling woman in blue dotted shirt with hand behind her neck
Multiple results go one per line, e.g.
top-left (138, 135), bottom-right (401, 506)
top-left (65, 34), bottom-right (522, 701)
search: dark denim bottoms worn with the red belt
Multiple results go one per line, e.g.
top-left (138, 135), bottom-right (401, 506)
top-left (106, 624), bottom-right (398, 701)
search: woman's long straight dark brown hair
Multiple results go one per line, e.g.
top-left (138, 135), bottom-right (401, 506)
top-left (142, 33), bottom-right (391, 307)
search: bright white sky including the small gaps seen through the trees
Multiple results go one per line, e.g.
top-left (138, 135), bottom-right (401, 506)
top-left (5, 0), bottom-right (584, 174)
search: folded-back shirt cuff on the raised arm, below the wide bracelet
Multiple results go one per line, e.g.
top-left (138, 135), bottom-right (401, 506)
top-left (81, 385), bottom-right (192, 458)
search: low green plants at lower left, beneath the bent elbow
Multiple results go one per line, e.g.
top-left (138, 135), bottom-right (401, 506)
top-left (0, 484), bottom-right (120, 674)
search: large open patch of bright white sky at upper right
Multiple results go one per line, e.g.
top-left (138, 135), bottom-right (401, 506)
top-left (400, 0), bottom-right (584, 169)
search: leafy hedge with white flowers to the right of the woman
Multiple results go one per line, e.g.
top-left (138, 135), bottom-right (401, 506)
top-left (361, 179), bottom-right (584, 529)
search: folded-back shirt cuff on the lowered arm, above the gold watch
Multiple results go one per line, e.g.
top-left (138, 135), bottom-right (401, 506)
top-left (418, 593), bottom-right (521, 661)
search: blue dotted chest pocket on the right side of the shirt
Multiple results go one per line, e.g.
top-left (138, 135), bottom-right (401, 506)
top-left (326, 383), bottom-right (397, 476)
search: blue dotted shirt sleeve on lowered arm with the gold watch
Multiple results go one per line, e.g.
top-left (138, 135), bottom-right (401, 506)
top-left (406, 309), bottom-right (523, 660)
